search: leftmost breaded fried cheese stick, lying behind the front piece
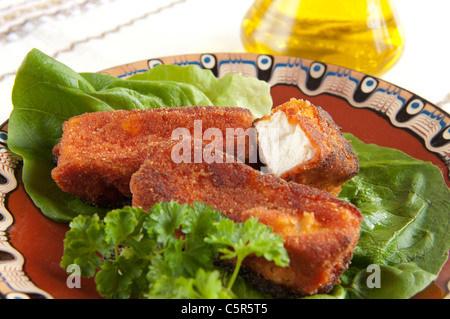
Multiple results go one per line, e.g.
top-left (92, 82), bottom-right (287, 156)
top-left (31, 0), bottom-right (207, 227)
top-left (52, 106), bottom-right (253, 207)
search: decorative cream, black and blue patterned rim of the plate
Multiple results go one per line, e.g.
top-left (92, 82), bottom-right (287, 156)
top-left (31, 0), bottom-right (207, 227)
top-left (0, 52), bottom-right (450, 299)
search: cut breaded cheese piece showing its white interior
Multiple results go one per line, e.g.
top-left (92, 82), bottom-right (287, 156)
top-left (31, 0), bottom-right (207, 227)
top-left (254, 99), bottom-right (359, 195)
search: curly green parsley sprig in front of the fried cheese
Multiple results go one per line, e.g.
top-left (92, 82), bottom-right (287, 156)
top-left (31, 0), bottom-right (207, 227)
top-left (61, 201), bottom-right (289, 299)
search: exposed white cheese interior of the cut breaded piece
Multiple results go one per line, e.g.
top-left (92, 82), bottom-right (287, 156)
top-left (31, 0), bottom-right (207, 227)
top-left (255, 111), bottom-right (316, 177)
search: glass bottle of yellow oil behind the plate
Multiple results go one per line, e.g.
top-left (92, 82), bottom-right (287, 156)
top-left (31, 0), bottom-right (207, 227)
top-left (241, 0), bottom-right (404, 76)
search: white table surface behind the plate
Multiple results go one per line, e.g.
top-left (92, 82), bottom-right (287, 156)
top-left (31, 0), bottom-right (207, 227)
top-left (0, 0), bottom-right (450, 122)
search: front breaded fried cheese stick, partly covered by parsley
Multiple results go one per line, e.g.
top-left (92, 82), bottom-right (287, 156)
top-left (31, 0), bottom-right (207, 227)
top-left (130, 141), bottom-right (362, 298)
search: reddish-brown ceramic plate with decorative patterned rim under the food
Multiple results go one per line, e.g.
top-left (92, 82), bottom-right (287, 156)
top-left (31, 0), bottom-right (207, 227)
top-left (0, 53), bottom-right (450, 298)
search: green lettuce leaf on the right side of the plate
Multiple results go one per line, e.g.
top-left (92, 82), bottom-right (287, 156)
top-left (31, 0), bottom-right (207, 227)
top-left (330, 134), bottom-right (450, 299)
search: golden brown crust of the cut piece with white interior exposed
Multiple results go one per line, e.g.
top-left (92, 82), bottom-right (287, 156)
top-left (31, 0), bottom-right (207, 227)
top-left (255, 99), bottom-right (359, 195)
